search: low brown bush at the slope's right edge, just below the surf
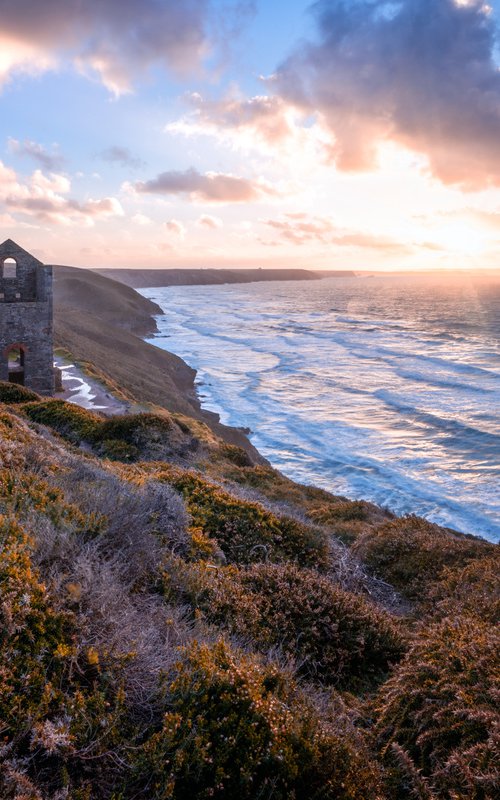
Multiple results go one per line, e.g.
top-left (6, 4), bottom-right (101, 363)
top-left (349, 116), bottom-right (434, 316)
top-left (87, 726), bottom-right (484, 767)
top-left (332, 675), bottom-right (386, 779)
top-left (353, 516), bottom-right (495, 600)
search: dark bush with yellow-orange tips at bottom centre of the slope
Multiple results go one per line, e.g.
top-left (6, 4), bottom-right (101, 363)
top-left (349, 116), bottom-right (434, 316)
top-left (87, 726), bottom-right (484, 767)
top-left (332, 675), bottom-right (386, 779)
top-left (136, 641), bottom-right (378, 800)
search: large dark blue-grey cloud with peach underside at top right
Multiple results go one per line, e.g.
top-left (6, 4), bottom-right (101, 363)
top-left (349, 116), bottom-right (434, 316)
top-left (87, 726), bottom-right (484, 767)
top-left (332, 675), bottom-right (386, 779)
top-left (278, 0), bottom-right (500, 188)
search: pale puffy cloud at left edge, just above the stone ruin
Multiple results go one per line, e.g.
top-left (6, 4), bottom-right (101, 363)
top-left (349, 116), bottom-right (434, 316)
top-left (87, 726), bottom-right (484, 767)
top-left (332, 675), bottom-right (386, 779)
top-left (0, 162), bottom-right (123, 227)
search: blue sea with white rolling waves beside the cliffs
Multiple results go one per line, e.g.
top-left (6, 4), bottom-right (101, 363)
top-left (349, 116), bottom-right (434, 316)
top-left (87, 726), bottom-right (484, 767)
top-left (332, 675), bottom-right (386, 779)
top-left (141, 272), bottom-right (500, 541)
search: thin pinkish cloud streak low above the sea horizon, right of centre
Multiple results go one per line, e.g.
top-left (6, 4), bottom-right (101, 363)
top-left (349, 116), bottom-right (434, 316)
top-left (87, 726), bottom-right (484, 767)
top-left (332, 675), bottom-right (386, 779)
top-left (264, 212), bottom-right (410, 253)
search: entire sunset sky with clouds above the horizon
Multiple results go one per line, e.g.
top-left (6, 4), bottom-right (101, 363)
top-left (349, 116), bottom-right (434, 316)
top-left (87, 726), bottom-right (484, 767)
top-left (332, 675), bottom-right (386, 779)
top-left (0, 0), bottom-right (500, 270)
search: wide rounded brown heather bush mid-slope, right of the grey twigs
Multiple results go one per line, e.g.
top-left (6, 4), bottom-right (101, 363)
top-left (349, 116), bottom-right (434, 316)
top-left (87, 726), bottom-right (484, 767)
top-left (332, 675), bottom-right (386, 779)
top-left (167, 564), bottom-right (404, 689)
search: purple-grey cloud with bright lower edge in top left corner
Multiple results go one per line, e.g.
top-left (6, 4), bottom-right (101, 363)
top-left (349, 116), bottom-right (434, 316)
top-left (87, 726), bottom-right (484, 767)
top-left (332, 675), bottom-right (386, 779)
top-left (0, 0), bottom-right (210, 94)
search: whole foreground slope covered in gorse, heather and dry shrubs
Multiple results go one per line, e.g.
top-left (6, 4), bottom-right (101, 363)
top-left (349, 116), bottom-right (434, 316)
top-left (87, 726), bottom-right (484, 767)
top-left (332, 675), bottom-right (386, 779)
top-left (0, 384), bottom-right (500, 800)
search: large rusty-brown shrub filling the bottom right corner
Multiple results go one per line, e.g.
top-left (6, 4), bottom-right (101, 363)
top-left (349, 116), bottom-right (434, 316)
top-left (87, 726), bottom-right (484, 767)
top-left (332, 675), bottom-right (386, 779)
top-left (375, 617), bottom-right (500, 800)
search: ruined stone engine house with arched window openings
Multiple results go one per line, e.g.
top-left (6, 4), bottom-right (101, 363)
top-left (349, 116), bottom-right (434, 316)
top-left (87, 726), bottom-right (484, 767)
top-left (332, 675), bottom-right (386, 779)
top-left (0, 239), bottom-right (54, 395)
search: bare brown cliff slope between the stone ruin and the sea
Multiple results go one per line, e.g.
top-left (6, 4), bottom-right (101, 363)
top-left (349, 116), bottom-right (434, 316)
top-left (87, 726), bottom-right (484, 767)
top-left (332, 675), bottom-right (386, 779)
top-left (54, 267), bottom-right (264, 455)
